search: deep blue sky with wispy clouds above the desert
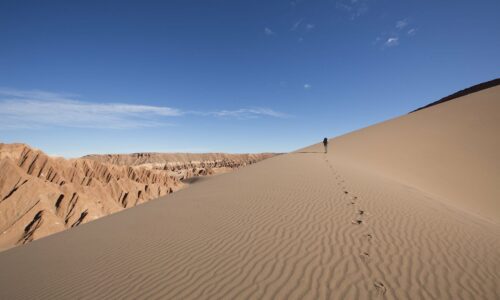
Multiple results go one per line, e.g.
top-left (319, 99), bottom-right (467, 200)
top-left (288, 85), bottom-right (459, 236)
top-left (0, 0), bottom-right (500, 157)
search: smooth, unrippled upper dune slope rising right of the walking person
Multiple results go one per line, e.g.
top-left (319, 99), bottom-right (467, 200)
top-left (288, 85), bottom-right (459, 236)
top-left (324, 86), bottom-right (500, 224)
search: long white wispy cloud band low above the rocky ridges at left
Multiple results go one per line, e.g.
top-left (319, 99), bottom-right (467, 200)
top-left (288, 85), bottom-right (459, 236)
top-left (0, 89), bottom-right (287, 129)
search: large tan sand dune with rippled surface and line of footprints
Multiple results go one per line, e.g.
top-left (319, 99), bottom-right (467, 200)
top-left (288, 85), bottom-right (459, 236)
top-left (0, 85), bottom-right (500, 299)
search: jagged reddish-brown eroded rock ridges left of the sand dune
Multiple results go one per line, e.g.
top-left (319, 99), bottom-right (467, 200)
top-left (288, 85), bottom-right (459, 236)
top-left (0, 144), bottom-right (182, 249)
